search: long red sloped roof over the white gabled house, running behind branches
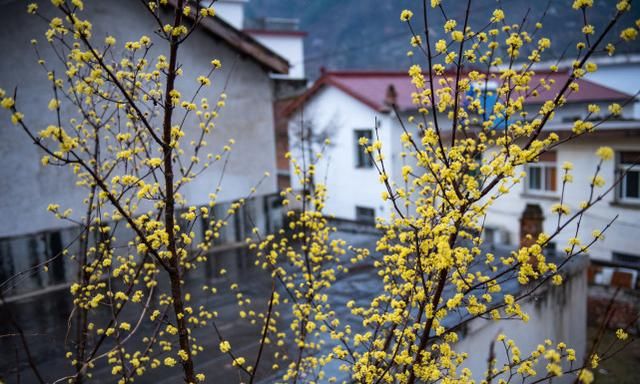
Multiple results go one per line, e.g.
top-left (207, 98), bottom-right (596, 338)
top-left (287, 71), bottom-right (632, 114)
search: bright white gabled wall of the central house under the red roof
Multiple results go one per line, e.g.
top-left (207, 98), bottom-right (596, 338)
top-left (289, 86), bottom-right (392, 219)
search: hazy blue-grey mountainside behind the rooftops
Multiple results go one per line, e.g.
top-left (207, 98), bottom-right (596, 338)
top-left (246, 0), bottom-right (640, 79)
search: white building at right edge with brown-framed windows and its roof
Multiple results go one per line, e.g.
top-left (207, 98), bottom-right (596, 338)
top-left (485, 55), bottom-right (640, 266)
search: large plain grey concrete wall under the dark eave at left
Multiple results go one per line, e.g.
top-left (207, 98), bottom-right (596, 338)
top-left (0, 0), bottom-right (276, 237)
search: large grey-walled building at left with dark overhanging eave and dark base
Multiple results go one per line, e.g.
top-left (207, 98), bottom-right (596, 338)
top-left (0, 0), bottom-right (289, 289)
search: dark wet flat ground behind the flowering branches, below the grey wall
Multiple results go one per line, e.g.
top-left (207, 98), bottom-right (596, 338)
top-left (0, 233), bottom-right (380, 383)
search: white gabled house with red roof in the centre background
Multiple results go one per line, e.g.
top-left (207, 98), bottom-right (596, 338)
top-left (287, 72), bottom-right (408, 221)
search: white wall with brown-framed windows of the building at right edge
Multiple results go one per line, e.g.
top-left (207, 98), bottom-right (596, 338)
top-left (486, 135), bottom-right (640, 260)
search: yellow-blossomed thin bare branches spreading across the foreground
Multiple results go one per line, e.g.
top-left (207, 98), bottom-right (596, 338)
top-left (0, 0), bottom-right (637, 383)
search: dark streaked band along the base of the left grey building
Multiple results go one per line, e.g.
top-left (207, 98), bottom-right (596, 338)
top-left (0, 194), bottom-right (284, 301)
